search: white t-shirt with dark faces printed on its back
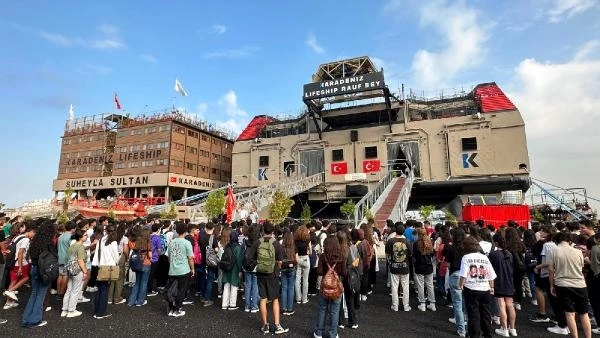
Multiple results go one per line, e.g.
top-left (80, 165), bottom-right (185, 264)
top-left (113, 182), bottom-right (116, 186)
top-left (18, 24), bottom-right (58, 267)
top-left (459, 252), bottom-right (496, 291)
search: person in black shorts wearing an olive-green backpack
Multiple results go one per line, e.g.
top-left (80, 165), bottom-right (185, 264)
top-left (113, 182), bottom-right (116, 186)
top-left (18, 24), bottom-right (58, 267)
top-left (256, 221), bottom-right (289, 334)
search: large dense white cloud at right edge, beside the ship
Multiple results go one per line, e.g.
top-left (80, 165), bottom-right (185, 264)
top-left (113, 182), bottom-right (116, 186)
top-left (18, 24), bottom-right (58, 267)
top-left (508, 42), bottom-right (600, 207)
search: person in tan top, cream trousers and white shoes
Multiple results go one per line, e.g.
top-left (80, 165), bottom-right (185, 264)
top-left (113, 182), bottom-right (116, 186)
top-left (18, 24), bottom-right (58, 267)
top-left (60, 230), bottom-right (89, 318)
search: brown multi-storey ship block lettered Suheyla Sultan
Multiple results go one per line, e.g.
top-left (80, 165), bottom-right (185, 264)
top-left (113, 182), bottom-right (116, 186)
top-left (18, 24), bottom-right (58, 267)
top-left (53, 111), bottom-right (233, 205)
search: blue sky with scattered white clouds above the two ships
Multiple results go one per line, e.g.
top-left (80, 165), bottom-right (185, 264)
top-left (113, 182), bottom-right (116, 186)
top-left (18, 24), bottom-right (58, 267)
top-left (0, 0), bottom-right (600, 207)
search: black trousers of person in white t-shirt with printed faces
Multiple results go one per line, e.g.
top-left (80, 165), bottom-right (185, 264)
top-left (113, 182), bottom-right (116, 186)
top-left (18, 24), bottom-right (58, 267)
top-left (463, 288), bottom-right (492, 338)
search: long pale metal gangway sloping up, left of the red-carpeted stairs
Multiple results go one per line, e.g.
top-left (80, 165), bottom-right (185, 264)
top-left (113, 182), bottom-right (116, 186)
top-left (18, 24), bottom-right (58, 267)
top-left (188, 172), bottom-right (324, 221)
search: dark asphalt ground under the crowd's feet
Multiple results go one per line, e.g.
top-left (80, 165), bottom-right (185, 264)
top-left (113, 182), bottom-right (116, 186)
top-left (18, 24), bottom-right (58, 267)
top-left (0, 266), bottom-right (583, 338)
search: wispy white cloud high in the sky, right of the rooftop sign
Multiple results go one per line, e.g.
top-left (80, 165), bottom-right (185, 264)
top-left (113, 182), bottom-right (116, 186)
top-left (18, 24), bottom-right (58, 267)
top-left (408, 0), bottom-right (488, 89)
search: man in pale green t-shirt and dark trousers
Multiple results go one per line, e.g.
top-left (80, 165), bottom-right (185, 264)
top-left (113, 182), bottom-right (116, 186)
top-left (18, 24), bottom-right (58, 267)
top-left (165, 223), bottom-right (195, 317)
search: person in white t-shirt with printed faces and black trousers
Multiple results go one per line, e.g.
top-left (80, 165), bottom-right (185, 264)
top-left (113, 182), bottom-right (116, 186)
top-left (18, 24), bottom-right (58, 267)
top-left (458, 237), bottom-right (496, 337)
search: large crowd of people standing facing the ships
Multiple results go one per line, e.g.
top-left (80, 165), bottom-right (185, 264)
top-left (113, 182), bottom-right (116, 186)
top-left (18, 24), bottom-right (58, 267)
top-left (0, 211), bottom-right (600, 338)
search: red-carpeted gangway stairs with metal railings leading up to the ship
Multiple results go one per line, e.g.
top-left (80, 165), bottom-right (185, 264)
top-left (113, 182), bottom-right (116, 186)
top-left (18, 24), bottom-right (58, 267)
top-left (354, 169), bottom-right (415, 227)
